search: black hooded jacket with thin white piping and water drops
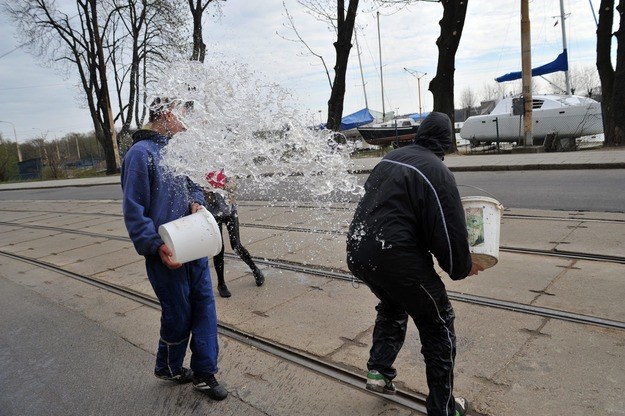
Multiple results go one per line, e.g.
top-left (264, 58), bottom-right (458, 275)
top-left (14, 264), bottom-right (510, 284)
top-left (347, 113), bottom-right (471, 280)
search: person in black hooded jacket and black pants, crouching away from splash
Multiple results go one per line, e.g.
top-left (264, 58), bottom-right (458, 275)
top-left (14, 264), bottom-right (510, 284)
top-left (347, 112), bottom-right (483, 416)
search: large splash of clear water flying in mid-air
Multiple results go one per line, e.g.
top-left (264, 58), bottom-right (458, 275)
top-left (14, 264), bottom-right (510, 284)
top-left (154, 61), bottom-right (362, 200)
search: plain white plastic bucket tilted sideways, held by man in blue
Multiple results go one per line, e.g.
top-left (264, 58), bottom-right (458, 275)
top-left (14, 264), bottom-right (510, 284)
top-left (158, 207), bottom-right (222, 263)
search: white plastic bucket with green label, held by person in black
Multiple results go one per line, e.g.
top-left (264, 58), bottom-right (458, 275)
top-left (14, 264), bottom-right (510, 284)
top-left (461, 196), bottom-right (503, 269)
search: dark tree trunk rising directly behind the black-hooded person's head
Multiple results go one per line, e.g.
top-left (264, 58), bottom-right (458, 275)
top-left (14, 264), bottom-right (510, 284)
top-left (429, 0), bottom-right (468, 153)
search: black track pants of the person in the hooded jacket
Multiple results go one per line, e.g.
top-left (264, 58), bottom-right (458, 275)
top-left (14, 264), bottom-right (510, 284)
top-left (352, 255), bottom-right (456, 416)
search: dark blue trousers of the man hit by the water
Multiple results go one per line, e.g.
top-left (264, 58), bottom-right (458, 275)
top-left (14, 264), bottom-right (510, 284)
top-left (145, 255), bottom-right (219, 377)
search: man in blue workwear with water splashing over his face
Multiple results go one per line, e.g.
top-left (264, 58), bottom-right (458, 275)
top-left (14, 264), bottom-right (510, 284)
top-left (121, 98), bottom-right (228, 400)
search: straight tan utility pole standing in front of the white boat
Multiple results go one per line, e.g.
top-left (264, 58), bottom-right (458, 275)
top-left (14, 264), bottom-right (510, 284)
top-left (521, 0), bottom-right (534, 146)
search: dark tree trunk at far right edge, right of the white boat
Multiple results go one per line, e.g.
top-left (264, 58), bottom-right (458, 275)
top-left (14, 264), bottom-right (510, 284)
top-left (597, 0), bottom-right (614, 146)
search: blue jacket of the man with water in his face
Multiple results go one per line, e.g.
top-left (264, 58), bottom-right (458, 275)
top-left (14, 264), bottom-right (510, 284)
top-left (121, 130), bottom-right (205, 256)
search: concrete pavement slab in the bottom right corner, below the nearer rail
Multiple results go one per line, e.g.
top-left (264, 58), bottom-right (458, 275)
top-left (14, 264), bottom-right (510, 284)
top-left (478, 321), bottom-right (625, 416)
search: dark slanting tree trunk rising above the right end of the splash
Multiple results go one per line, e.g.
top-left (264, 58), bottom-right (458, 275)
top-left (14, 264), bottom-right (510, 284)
top-left (326, 0), bottom-right (358, 131)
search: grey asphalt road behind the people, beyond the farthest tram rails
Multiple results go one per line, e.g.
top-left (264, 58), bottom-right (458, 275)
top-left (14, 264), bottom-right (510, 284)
top-left (0, 169), bottom-right (625, 212)
